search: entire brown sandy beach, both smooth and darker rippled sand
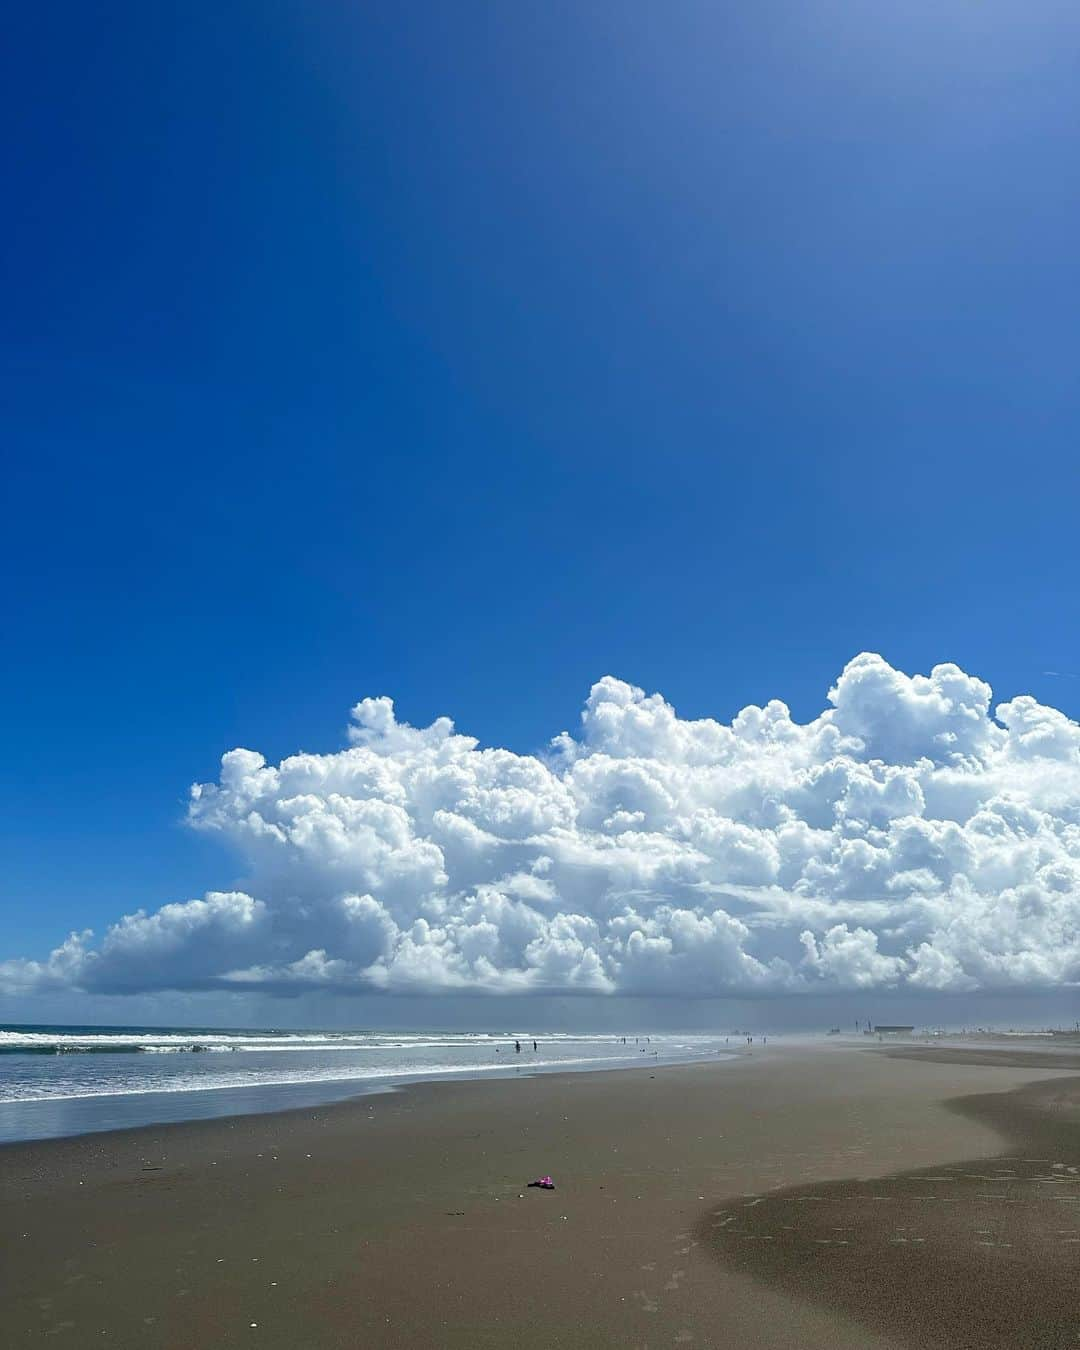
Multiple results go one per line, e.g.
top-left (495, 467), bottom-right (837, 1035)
top-left (0, 1044), bottom-right (1080, 1350)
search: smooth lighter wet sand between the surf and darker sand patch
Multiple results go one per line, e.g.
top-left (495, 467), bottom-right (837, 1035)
top-left (0, 1045), bottom-right (1077, 1350)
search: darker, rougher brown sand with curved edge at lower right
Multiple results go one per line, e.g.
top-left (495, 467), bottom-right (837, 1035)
top-left (695, 1049), bottom-right (1080, 1350)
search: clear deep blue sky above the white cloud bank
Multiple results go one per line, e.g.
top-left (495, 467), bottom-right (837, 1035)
top-left (0, 0), bottom-right (1080, 1015)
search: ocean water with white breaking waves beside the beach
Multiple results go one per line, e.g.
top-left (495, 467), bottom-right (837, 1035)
top-left (0, 1025), bottom-right (738, 1143)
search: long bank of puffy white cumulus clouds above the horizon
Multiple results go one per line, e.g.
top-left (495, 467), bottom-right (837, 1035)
top-left (8, 652), bottom-right (1080, 998)
